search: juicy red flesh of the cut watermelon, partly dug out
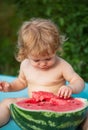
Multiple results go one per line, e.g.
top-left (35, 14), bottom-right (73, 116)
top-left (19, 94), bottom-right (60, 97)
top-left (17, 91), bottom-right (84, 112)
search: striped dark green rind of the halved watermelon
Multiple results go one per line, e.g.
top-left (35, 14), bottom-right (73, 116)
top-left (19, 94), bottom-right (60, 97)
top-left (10, 98), bottom-right (88, 130)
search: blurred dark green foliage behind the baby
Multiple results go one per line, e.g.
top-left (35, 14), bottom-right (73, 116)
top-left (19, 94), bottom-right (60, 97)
top-left (0, 0), bottom-right (88, 81)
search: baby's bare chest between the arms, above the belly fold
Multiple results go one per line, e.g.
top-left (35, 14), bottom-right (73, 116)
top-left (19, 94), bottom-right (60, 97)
top-left (25, 68), bottom-right (63, 85)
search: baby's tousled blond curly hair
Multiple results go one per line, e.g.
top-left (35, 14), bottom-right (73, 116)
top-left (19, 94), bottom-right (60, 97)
top-left (16, 18), bottom-right (61, 61)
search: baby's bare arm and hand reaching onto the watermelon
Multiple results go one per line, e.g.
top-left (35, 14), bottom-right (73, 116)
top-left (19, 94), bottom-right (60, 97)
top-left (58, 61), bottom-right (84, 97)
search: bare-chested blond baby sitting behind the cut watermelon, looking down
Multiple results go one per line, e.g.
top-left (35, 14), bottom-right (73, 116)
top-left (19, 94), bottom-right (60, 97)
top-left (0, 18), bottom-right (84, 126)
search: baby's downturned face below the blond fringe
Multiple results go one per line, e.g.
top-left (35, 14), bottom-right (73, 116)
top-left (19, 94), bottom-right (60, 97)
top-left (29, 54), bottom-right (56, 69)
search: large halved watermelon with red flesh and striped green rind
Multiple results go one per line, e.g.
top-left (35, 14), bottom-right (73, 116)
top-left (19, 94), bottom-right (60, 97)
top-left (10, 91), bottom-right (88, 130)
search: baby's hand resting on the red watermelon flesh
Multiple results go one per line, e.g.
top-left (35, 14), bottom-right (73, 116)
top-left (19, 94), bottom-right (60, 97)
top-left (58, 85), bottom-right (72, 98)
